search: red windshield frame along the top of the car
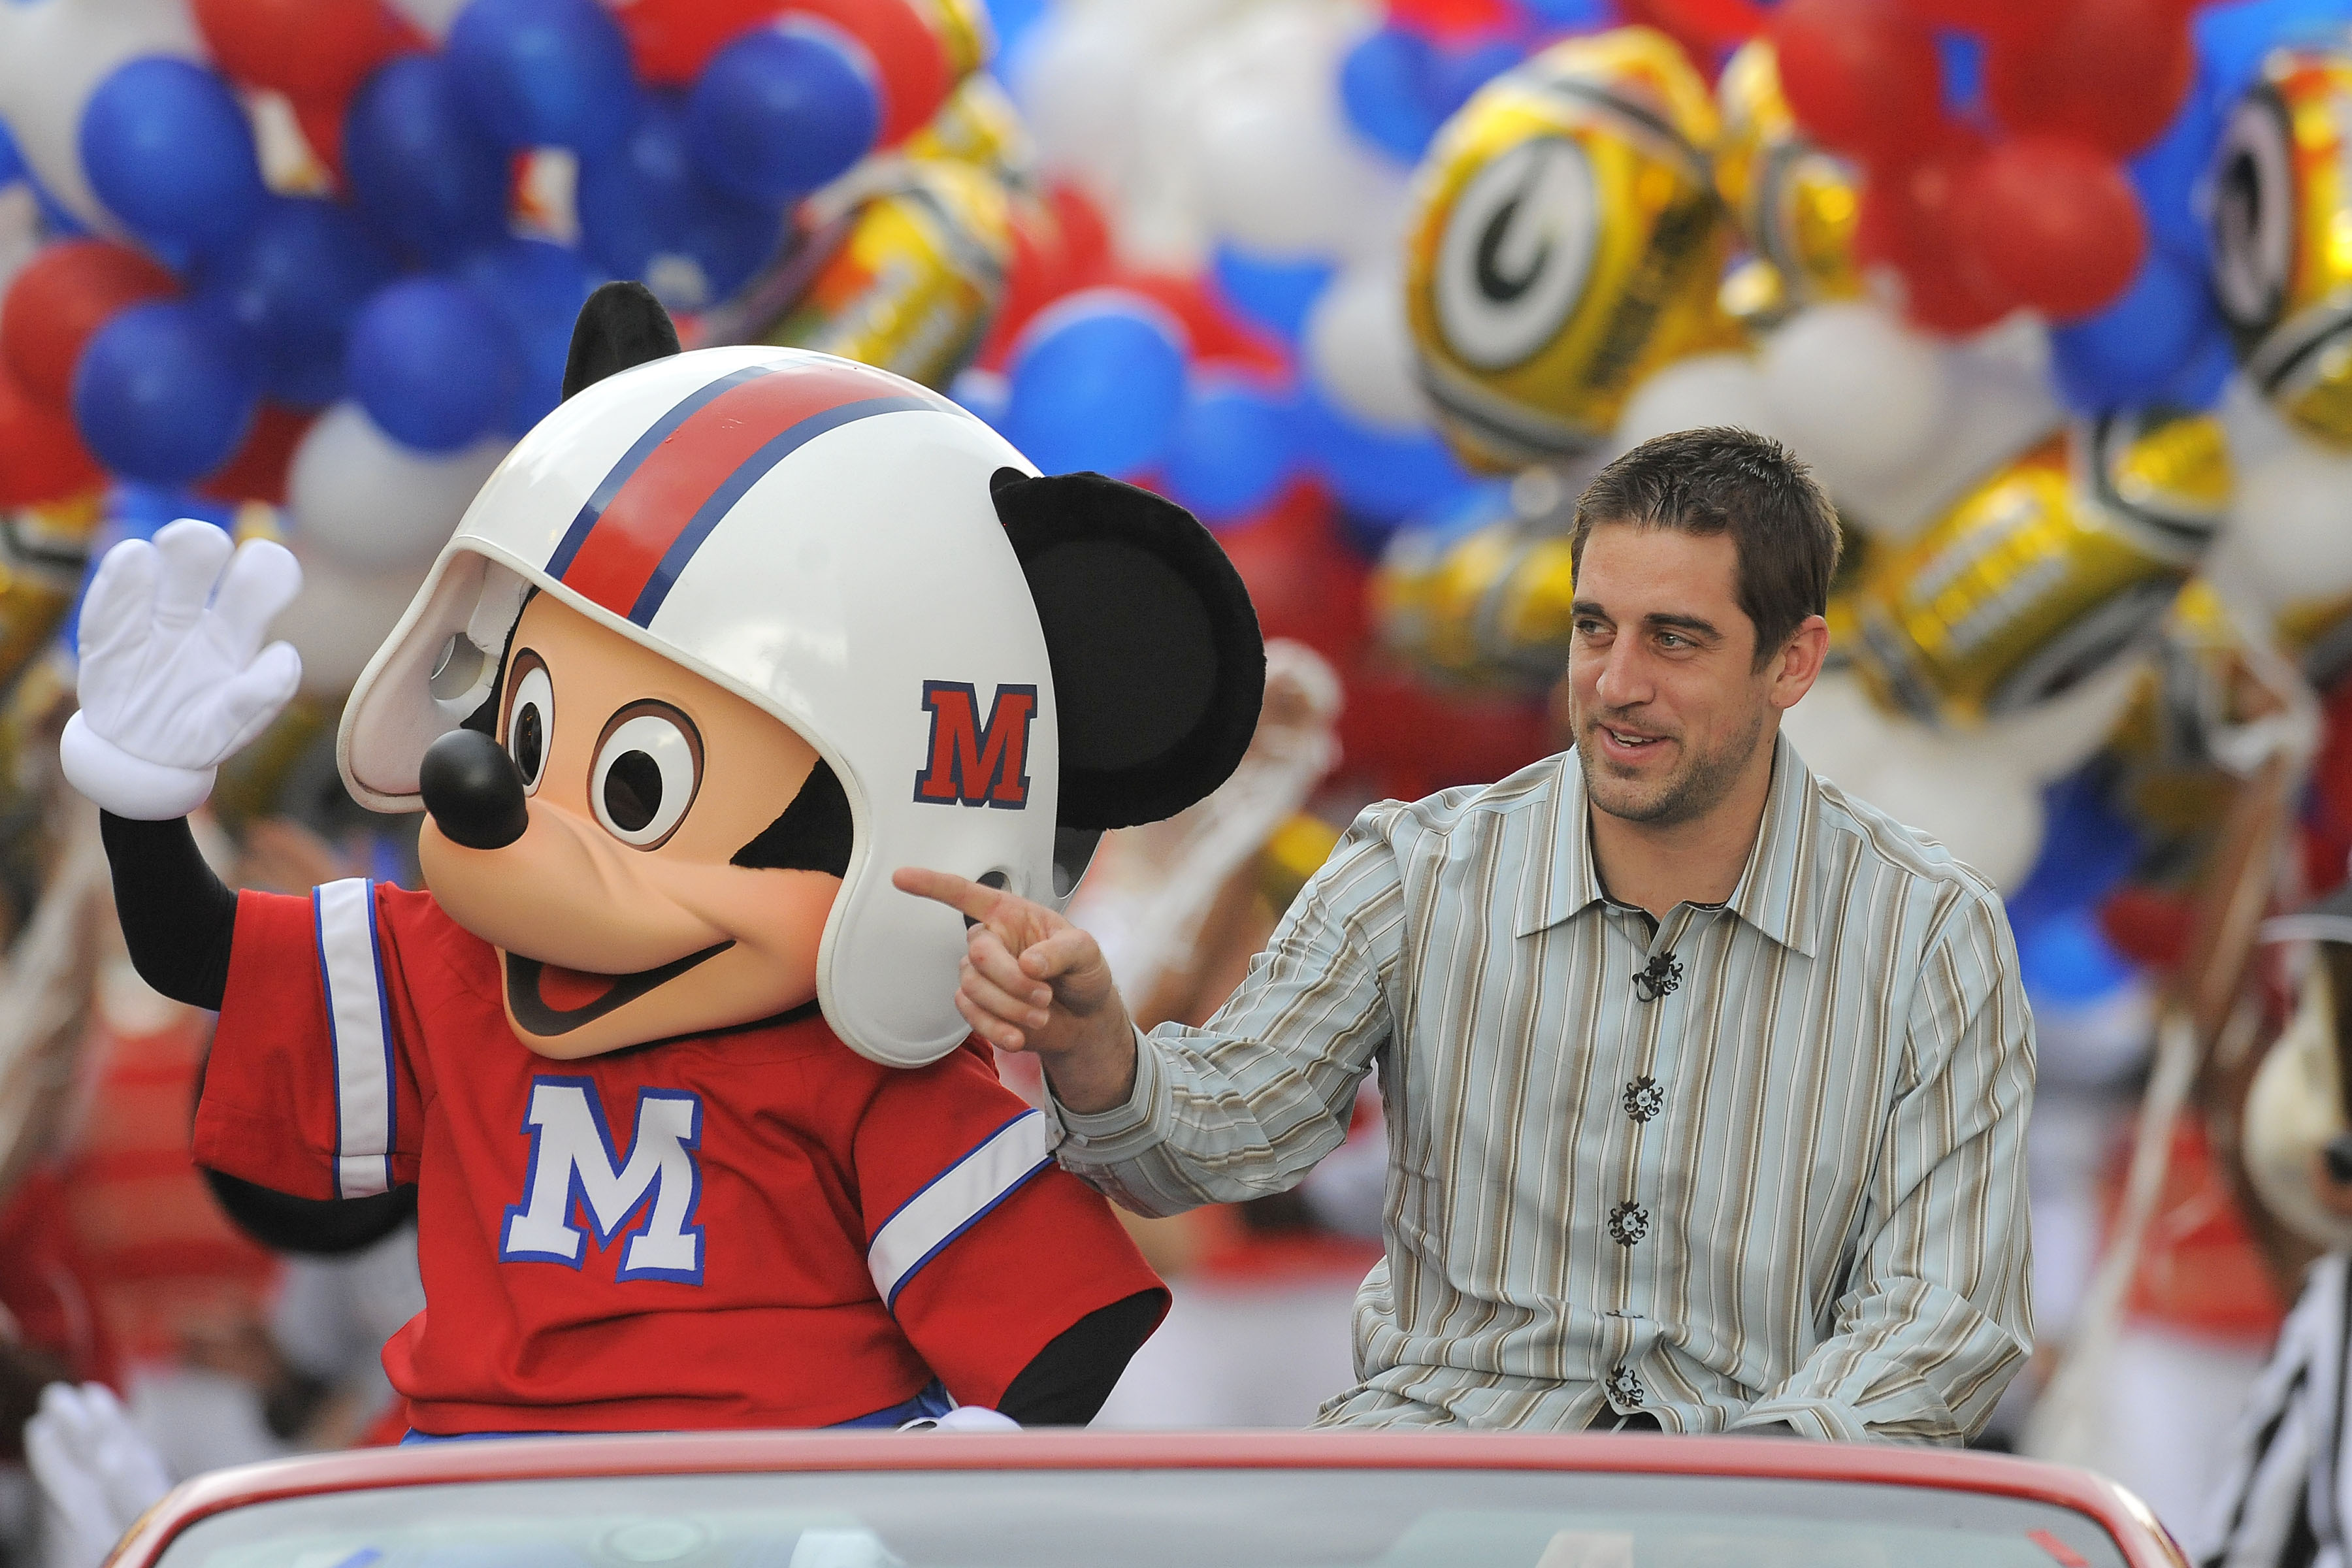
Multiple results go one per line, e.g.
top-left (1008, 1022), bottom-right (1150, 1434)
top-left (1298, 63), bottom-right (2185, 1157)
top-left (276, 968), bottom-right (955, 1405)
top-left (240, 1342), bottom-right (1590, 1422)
top-left (108, 1429), bottom-right (2187, 1568)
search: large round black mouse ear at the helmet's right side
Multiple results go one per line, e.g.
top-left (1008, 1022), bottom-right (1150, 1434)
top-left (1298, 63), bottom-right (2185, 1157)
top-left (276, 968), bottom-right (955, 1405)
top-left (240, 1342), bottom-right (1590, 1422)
top-left (988, 468), bottom-right (1266, 828)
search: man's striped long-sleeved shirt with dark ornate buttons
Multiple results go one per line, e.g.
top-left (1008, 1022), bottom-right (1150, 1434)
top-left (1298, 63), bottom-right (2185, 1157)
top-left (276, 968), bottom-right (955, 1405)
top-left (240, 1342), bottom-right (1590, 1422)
top-left (1056, 738), bottom-right (2034, 1441)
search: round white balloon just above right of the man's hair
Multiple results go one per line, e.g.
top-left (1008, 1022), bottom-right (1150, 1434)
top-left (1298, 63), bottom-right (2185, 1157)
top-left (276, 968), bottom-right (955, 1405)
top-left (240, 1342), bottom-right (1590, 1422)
top-left (1759, 301), bottom-right (1948, 494)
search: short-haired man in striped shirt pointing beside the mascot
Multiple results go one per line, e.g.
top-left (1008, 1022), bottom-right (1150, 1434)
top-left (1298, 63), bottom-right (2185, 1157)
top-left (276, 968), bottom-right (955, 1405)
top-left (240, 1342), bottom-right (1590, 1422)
top-left (898, 430), bottom-right (2034, 1443)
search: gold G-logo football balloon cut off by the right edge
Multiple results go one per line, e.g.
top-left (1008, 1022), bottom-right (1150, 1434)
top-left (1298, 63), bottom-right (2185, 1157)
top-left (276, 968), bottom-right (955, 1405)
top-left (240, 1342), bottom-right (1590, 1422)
top-left (2213, 42), bottom-right (2352, 447)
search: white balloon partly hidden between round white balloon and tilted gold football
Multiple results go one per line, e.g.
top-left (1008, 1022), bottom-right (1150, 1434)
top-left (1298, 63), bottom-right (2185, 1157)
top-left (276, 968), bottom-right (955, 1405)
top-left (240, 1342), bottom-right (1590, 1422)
top-left (1832, 348), bottom-right (2065, 543)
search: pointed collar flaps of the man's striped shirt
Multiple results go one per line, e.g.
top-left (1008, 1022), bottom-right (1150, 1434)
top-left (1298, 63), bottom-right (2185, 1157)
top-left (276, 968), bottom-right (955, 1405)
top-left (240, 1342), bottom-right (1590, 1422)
top-left (1514, 736), bottom-right (1820, 956)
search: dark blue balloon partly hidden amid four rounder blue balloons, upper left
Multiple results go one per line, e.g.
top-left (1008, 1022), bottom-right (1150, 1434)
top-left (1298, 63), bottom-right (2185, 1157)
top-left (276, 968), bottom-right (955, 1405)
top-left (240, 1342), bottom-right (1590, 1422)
top-left (197, 195), bottom-right (397, 406)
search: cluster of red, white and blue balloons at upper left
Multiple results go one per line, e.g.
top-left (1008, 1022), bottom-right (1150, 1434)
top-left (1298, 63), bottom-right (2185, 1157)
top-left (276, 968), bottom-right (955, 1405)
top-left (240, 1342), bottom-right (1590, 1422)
top-left (0, 0), bottom-right (1002, 693)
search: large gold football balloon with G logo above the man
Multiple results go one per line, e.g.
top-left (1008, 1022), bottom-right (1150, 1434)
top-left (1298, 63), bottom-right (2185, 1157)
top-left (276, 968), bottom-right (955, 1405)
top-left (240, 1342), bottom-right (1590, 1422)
top-left (1404, 28), bottom-right (1724, 470)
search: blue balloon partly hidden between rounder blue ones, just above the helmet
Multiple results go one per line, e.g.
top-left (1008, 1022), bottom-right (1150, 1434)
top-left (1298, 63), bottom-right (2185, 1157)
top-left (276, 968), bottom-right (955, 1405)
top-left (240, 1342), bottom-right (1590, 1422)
top-left (576, 94), bottom-right (783, 310)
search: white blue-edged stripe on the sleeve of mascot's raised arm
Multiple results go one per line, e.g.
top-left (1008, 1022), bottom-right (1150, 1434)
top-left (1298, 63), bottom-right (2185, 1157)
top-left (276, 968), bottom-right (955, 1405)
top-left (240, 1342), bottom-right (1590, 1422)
top-left (310, 877), bottom-right (393, 1199)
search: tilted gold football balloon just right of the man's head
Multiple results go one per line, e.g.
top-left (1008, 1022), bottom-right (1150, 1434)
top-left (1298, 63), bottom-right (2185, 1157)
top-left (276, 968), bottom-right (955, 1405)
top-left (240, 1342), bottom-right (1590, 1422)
top-left (1854, 414), bottom-right (2230, 722)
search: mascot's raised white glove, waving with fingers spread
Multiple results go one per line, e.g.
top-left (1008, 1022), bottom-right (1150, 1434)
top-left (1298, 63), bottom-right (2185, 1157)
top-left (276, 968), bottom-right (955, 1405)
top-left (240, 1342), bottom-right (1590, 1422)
top-left (59, 517), bottom-right (301, 823)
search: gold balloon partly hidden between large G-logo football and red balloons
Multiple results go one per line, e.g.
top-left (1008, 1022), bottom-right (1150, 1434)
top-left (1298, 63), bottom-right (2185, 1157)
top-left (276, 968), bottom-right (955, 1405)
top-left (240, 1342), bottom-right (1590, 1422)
top-left (1714, 38), bottom-right (1863, 308)
